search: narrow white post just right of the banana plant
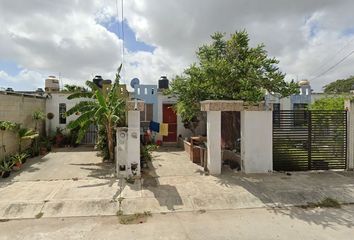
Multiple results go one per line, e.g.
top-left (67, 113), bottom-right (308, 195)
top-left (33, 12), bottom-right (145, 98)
top-left (126, 110), bottom-right (140, 176)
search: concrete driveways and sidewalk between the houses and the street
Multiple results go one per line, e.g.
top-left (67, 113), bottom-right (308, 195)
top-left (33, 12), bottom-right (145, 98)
top-left (0, 145), bottom-right (354, 219)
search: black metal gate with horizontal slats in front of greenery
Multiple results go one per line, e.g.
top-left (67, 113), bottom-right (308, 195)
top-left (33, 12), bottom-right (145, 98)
top-left (273, 110), bottom-right (347, 171)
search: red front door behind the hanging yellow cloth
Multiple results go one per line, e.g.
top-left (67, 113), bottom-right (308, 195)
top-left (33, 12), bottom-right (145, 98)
top-left (162, 104), bottom-right (177, 142)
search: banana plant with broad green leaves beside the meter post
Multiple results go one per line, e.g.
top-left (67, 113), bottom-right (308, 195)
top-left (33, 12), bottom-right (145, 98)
top-left (66, 65), bottom-right (125, 161)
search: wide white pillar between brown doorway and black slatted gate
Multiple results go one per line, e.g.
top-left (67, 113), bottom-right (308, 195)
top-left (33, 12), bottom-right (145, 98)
top-left (241, 111), bottom-right (273, 173)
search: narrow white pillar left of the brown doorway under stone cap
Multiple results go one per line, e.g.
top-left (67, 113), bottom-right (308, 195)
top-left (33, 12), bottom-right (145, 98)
top-left (207, 111), bottom-right (221, 175)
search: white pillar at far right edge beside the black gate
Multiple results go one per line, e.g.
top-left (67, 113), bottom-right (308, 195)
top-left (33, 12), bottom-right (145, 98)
top-left (345, 100), bottom-right (354, 170)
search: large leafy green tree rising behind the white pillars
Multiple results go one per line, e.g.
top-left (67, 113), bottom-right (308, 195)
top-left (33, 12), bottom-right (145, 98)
top-left (168, 31), bottom-right (298, 130)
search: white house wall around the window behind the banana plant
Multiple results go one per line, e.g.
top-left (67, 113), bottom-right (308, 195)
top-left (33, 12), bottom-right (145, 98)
top-left (46, 93), bottom-right (85, 133)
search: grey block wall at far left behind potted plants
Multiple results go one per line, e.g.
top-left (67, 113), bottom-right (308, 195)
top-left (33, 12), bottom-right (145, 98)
top-left (0, 93), bottom-right (46, 160)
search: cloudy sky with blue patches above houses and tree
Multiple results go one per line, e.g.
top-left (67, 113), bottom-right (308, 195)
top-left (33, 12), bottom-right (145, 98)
top-left (0, 0), bottom-right (354, 92)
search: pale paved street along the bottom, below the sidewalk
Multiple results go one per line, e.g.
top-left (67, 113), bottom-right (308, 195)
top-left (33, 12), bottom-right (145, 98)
top-left (0, 206), bottom-right (354, 240)
